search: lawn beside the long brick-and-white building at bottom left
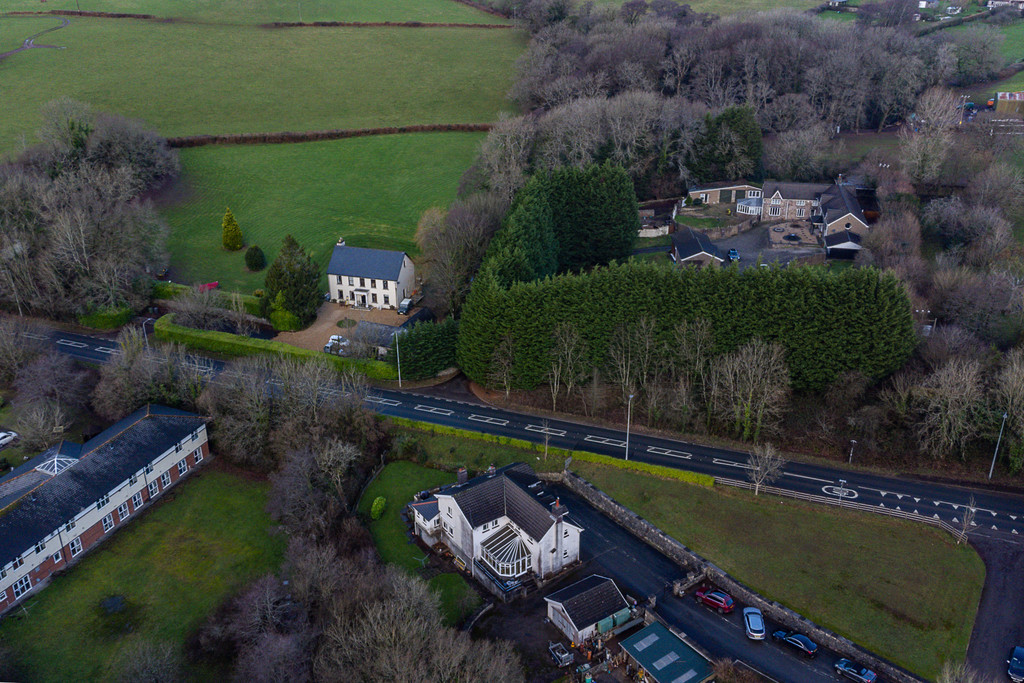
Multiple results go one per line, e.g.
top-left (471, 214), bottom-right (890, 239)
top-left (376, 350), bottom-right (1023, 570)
top-left (0, 469), bottom-right (284, 683)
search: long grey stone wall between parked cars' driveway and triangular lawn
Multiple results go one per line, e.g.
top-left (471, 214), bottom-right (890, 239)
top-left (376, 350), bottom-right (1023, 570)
top-left (544, 472), bottom-right (925, 683)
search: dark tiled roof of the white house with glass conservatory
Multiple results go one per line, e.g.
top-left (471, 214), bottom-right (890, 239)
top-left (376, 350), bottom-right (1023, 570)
top-left (438, 463), bottom-right (555, 541)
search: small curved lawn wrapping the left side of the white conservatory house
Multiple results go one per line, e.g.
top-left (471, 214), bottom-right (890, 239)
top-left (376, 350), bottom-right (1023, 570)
top-left (359, 462), bottom-right (480, 625)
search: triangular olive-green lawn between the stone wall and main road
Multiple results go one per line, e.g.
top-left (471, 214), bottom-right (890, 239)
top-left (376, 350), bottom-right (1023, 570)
top-left (572, 463), bottom-right (985, 680)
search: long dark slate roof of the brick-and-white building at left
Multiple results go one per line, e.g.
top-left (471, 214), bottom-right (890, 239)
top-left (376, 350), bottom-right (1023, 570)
top-left (0, 405), bottom-right (205, 566)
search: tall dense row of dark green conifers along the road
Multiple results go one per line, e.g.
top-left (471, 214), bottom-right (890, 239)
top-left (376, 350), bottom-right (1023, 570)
top-left (457, 261), bottom-right (915, 389)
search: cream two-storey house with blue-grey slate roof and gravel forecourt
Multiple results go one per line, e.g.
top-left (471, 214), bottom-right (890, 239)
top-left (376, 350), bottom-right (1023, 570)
top-left (327, 240), bottom-right (416, 308)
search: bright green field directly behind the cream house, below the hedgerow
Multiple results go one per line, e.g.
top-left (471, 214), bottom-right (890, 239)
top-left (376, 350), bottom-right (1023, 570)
top-left (160, 133), bottom-right (483, 292)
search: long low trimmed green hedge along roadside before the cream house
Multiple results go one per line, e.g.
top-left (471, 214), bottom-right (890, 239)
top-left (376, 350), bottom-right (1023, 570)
top-left (154, 313), bottom-right (397, 381)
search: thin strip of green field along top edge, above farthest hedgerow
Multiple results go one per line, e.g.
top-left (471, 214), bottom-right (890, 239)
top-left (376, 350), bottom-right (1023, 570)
top-left (3, 0), bottom-right (504, 24)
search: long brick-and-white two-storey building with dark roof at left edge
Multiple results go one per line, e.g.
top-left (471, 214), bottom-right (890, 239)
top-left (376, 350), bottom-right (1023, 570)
top-left (0, 405), bottom-right (210, 613)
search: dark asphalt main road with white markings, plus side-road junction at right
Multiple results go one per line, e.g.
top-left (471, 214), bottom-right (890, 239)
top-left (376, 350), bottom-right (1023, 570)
top-left (49, 332), bottom-right (1024, 673)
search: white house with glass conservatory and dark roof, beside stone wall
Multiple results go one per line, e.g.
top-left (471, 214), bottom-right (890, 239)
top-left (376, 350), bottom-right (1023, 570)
top-left (410, 463), bottom-right (583, 600)
